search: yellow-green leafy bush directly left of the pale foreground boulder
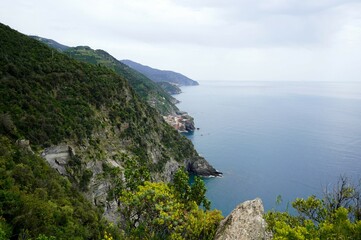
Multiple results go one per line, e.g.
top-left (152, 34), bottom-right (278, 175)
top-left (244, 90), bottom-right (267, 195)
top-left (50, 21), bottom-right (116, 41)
top-left (120, 168), bottom-right (222, 239)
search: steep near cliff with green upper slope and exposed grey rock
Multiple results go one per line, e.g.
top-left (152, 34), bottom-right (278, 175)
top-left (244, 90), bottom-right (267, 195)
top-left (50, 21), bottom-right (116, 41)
top-left (0, 24), bottom-right (219, 225)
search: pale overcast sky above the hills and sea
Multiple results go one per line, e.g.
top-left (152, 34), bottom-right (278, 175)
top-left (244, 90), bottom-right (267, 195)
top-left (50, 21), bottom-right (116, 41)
top-left (0, 0), bottom-right (361, 81)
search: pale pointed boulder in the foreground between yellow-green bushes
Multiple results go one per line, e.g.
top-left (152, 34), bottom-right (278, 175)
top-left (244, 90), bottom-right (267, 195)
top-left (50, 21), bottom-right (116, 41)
top-left (215, 198), bottom-right (272, 240)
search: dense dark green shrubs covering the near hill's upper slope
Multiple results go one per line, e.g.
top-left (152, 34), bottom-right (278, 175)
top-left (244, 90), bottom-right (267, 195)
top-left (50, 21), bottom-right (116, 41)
top-left (0, 26), bottom-right (125, 145)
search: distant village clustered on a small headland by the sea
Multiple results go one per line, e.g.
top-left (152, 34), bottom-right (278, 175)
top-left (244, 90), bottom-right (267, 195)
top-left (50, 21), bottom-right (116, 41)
top-left (163, 112), bottom-right (195, 132)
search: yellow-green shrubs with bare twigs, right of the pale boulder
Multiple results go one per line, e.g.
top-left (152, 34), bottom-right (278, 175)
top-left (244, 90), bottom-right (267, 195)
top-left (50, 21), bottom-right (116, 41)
top-left (265, 177), bottom-right (361, 240)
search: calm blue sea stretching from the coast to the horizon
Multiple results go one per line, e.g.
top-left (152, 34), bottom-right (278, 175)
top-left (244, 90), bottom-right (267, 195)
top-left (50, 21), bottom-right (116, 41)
top-left (177, 82), bottom-right (361, 215)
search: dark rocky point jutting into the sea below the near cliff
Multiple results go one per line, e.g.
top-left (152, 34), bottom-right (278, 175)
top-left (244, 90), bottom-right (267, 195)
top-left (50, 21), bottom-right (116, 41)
top-left (185, 156), bottom-right (222, 177)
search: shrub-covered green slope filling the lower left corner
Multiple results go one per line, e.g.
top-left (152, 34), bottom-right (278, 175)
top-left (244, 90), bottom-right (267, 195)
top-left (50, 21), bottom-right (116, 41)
top-left (0, 135), bottom-right (116, 240)
